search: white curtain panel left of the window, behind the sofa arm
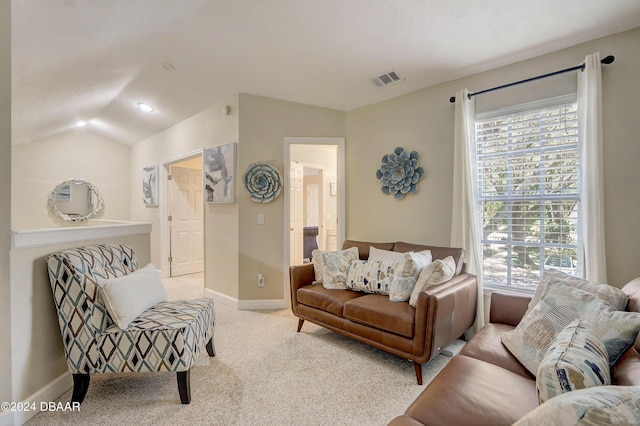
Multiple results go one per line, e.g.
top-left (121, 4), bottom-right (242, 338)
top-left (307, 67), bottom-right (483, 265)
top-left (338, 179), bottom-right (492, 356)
top-left (451, 89), bottom-right (484, 331)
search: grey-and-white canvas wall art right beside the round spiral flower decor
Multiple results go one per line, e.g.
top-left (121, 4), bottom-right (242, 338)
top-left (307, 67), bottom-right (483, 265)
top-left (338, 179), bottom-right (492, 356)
top-left (202, 142), bottom-right (237, 203)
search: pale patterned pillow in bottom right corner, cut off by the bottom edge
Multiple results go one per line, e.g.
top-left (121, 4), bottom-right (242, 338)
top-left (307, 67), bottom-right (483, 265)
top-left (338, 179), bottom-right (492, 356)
top-left (513, 386), bottom-right (640, 426)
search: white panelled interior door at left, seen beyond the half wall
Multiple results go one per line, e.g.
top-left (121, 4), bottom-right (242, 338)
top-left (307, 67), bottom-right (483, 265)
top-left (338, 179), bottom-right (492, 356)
top-left (170, 166), bottom-right (204, 277)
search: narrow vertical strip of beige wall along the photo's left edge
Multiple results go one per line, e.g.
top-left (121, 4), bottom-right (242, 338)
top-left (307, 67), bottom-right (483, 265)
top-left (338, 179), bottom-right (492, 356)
top-left (0, 0), bottom-right (12, 410)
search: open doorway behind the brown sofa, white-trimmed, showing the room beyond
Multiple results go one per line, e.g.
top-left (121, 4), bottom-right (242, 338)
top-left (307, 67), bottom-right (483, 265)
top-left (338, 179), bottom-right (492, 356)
top-left (284, 137), bottom-right (345, 295)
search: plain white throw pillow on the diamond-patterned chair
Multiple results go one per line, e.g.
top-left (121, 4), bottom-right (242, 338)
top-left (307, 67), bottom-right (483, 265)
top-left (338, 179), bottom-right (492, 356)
top-left (98, 264), bottom-right (167, 330)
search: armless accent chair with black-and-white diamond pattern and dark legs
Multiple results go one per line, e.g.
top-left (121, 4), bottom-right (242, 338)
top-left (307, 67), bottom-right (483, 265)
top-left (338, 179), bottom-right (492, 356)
top-left (47, 244), bottom-right (215, 404)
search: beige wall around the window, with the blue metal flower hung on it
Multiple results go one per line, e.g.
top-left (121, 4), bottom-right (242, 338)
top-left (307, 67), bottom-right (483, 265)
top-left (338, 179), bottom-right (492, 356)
top-left (346, 28), bottom-right (640, 287)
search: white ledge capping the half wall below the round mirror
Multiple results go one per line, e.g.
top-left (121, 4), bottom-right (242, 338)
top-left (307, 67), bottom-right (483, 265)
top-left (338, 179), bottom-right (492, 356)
top-left (11, 220), bottom-right (152, 250)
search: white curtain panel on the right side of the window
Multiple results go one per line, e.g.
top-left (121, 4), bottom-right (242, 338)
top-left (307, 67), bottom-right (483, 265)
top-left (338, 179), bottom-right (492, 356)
top-left (578, 52), bottom-right (607, 283)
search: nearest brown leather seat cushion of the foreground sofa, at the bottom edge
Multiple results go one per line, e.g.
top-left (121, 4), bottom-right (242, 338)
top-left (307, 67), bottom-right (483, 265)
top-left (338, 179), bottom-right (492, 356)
top-left (405, 355), bottom-right (538, 425)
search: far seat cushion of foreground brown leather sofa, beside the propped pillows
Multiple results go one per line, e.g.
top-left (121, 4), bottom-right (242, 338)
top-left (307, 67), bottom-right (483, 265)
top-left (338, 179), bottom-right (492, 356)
top-left (460, 323), bottom-right (535, 380)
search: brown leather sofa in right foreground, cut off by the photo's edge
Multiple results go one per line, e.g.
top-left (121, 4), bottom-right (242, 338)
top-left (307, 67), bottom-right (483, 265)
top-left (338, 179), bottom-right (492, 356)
top-left (390, 278), bottom-right (640, 426)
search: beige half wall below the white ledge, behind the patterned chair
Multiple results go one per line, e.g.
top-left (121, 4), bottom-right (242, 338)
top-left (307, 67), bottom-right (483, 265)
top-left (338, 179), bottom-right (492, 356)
top-left (11, 234), bottom-right (150, 406)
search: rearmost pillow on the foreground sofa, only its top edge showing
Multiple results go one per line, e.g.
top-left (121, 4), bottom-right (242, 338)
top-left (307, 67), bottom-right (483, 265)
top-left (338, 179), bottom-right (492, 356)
top-left (525, 269), bottom-right (628, 315)
